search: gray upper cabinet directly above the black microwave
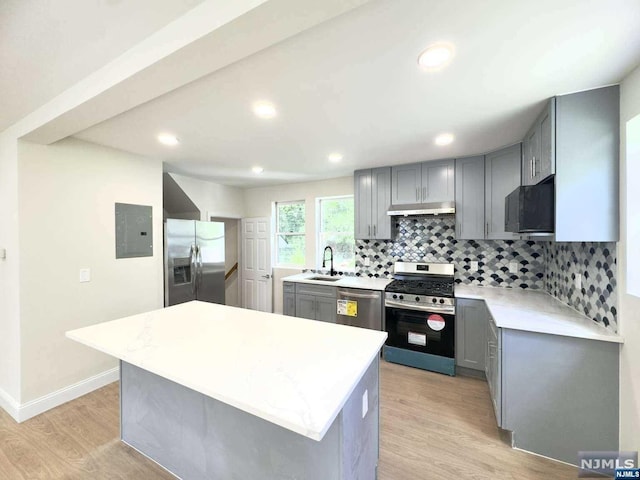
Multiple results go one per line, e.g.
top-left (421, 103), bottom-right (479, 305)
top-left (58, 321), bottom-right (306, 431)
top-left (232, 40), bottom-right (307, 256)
top-left (522, 98), bottom-right (556, 185)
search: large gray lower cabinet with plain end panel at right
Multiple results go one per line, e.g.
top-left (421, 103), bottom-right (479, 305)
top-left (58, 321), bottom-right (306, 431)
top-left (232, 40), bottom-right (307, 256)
top-left (485, 314), bottom-right (620, 464)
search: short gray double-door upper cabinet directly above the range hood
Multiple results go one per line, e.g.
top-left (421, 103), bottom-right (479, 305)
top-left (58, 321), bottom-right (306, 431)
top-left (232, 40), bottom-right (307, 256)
top-left (391, 159), bottom-right (455, 205)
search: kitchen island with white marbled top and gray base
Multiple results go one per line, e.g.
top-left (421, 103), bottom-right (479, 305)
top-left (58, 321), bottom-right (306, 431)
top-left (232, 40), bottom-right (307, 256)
top-left (67, 302), bottom-right (386, 480)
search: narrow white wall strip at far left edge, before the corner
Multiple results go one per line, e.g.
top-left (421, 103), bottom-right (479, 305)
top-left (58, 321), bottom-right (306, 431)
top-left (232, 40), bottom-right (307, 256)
top-left (0, 134), bottom-right (20, 411)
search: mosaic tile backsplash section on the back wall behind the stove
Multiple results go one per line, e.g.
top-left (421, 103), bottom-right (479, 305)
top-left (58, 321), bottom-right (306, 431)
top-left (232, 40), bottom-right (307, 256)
top-left (356, 215), bottom-right (545, 290)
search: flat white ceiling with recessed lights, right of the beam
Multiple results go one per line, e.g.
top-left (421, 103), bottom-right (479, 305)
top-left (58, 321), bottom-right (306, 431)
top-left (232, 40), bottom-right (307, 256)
top-left (66, 0), bottom-right (640, 186)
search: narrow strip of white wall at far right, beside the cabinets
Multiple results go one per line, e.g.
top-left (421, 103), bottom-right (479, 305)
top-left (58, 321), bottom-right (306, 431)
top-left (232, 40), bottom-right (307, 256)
top-left (618, 67), bottom-right (640, 451)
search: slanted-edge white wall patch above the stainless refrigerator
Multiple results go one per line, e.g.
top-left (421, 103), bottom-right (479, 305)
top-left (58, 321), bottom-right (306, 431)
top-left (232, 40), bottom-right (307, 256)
top-left (169, 173), bottom-right (245, 221)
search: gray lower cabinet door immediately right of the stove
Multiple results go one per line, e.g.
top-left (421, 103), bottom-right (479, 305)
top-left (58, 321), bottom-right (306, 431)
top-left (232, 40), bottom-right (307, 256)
top-left (456, 299), bottom-right (489, 371)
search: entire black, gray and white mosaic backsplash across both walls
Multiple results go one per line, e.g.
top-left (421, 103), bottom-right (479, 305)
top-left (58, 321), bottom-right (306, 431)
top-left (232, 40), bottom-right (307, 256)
top-left (355, 215), bottom-right (617, 331)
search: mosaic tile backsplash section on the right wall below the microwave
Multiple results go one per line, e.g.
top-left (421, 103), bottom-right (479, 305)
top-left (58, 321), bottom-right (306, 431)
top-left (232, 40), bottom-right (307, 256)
top-left (545, 242), bottom-right (618, 331)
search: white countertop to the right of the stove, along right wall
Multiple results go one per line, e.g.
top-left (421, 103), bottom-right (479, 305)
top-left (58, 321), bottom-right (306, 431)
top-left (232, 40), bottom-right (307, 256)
top-left (455, 285), bottom-right (624, 343)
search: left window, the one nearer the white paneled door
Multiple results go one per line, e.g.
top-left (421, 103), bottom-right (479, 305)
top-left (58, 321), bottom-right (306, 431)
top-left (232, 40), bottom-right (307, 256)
top-left (276, 200), bottom-right (305, 267)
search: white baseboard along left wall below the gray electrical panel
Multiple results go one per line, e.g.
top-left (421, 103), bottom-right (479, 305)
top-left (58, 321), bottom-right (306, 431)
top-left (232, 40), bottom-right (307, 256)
top-left (0, 367), bottom-right (120, 423)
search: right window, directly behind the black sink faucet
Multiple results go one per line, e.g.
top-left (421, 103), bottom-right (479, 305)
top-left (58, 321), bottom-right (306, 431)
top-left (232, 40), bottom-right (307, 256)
top-left (318, 196), bottom-right (356, 270)
